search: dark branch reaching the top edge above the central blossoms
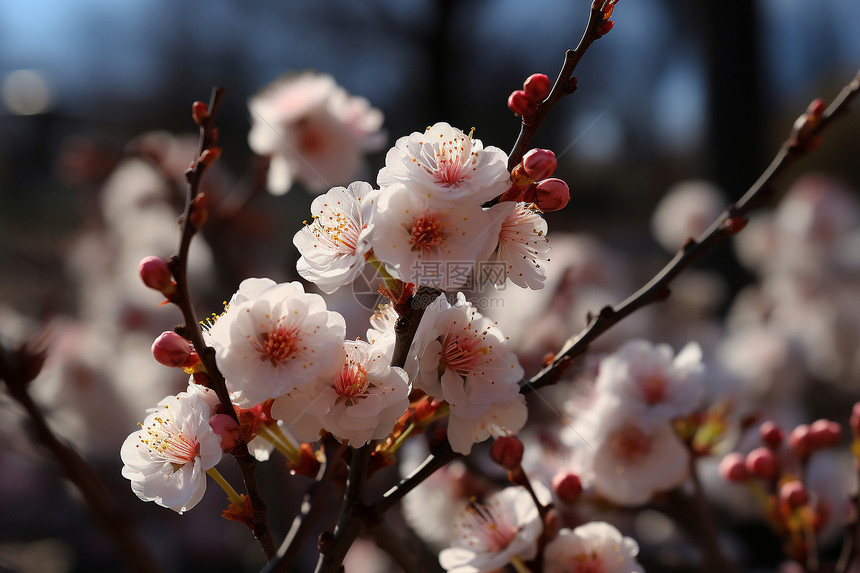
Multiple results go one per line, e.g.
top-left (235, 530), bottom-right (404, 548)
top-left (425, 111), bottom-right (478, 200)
top-left (508, 0), bottom-right (608, 171)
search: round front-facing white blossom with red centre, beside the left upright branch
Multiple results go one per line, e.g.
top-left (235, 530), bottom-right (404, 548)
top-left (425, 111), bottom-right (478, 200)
top-left (207, 279), bottom-right (346, 408)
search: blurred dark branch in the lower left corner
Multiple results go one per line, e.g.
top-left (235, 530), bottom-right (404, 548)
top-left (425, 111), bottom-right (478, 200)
top-left (0, 345), bottom-right (161, 573)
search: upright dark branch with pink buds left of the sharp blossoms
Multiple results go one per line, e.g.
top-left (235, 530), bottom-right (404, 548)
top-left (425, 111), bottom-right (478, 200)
top-left (170, 88), bottom-right (275, 559)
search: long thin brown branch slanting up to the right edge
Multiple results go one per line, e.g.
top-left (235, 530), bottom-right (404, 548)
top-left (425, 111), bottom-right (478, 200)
top-left (522, 67), bottom-right (860, 389)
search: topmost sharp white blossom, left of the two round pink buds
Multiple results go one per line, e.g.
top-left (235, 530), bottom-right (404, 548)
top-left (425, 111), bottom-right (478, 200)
top-left (377, 122), bottom-right (510, 205)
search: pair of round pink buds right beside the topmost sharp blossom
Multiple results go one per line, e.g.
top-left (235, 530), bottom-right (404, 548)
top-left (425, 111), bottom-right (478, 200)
top-left (499, 149), bottom-right (570, 213)
